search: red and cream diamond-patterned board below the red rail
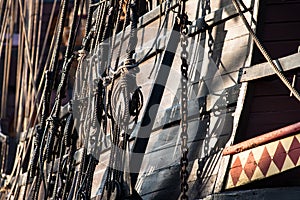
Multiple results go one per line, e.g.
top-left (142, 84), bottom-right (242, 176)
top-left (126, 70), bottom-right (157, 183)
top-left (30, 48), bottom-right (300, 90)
top-left (226, 134), bottom-right (300, 189)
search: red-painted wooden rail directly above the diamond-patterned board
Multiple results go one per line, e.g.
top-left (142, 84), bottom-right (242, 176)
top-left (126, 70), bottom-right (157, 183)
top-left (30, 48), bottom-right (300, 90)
top-left (223, 122), bottom-right (300, 156)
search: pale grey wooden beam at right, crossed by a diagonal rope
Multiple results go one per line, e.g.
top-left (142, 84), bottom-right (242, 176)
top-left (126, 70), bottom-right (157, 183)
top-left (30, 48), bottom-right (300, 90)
top-left (241, 53), bottom-right (300, 82)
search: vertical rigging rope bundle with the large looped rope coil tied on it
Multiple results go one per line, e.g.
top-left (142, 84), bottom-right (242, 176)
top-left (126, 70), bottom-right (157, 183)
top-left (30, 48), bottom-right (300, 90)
top-left (104, 0), bottom-right (142, 199)
